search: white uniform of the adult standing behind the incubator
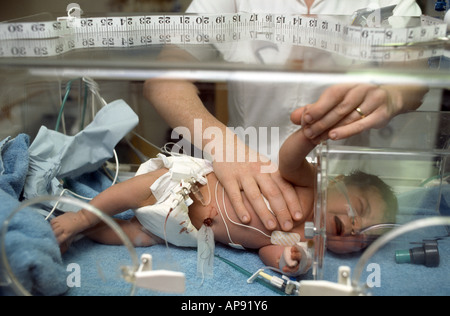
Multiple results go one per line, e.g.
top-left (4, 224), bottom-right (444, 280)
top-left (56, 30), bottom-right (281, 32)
top-left (187, 0), bottom-right (421, 162)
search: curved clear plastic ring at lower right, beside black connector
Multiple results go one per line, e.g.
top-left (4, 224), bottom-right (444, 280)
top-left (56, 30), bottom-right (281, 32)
top-left (352, 217), bottom-right (450, 289)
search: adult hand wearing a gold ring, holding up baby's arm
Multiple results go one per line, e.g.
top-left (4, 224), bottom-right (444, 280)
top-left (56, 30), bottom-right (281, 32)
top-left (291, 84), bottom-right (428, 142)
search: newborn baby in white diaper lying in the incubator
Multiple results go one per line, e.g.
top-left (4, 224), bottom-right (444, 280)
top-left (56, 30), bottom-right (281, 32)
top-left (51, 130), bottom-right (398, 275)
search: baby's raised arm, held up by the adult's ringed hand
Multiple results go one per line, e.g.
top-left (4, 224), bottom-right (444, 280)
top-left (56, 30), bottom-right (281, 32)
top-left (279, 129), bottom-right (316, 187)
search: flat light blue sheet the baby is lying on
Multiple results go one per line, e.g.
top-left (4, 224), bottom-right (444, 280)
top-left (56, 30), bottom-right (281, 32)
top-left (60, 186), bottom-right (450, 296)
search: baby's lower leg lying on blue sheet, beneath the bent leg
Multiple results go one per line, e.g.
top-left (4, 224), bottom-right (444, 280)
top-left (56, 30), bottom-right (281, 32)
top-left (85, 217), bottom-right (164, 247)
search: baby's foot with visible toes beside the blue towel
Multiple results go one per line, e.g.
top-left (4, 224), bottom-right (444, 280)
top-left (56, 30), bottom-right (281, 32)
top-left (51, 212), bottom-right (89, 253)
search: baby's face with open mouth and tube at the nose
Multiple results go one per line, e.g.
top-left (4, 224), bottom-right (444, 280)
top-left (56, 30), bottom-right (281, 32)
top-left (327, 186), bottom-right (386, 254)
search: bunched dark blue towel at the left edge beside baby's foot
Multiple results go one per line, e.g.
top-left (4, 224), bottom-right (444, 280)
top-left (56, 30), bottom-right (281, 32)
top-left (0, 135), bottom-right (67, 295)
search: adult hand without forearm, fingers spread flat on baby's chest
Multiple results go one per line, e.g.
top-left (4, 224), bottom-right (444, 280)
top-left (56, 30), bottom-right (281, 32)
top-left (213, 141), bottom-right (303, 231)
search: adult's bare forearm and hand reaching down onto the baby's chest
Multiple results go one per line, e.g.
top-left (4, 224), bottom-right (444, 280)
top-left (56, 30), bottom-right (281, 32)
top-left (145, 75), bottom-right (302, 231)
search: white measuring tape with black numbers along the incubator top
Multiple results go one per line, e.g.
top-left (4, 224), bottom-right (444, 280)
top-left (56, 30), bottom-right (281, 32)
top-left (0, 13), bottom-right (447, 61)
